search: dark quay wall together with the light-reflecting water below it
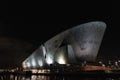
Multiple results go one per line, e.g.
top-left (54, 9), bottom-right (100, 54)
top-left (0, 71), bottom-right (120, 80)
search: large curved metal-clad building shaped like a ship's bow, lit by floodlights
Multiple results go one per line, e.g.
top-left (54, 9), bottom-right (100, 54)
top-left (23, 21), bottom-right (106, 68)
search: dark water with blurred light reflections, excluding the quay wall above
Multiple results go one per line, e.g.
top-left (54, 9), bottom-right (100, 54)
top-left (0, 75), bottom-right (120, 80)
